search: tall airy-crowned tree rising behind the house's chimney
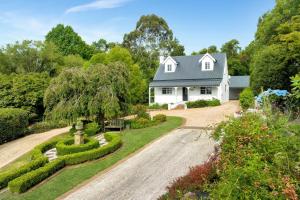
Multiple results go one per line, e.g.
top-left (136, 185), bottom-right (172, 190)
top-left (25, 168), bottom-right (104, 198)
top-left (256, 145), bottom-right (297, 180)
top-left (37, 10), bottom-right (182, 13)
top-left (123, 15), bottom-right (184, 79)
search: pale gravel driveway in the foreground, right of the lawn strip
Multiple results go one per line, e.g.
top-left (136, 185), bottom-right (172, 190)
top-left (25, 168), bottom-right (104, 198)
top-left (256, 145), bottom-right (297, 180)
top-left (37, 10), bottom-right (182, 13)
top-left (64, 129), bottom-right (214, 200)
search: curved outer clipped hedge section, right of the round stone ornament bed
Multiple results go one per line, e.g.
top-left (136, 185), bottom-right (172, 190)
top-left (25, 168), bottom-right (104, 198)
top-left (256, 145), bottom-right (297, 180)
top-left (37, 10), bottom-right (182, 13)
top-left (61, 133), bottom-right (122, 165)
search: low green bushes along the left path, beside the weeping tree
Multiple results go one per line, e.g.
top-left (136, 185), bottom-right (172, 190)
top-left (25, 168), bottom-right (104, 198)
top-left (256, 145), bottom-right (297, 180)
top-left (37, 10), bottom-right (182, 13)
top-left (29, 121), bottom-right (68, 133)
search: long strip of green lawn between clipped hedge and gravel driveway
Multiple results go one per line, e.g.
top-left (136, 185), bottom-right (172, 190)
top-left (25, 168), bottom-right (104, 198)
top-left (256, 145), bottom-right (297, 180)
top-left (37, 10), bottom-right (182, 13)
top-left (0, 117), bottom-right (183, 200)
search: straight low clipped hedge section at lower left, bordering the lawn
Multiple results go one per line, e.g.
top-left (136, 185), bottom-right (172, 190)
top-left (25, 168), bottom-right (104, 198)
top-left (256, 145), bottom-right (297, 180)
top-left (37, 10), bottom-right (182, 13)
top-left (8, 158), bottom-right (65, 193)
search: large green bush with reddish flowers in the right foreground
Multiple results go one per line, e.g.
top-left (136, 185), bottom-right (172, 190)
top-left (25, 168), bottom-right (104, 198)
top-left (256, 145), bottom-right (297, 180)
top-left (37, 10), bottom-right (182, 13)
top-left (209, 113), bottom-right (300, 199)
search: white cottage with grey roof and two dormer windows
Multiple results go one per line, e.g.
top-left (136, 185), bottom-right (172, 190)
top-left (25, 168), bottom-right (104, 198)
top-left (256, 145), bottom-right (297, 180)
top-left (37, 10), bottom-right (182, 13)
top-left (149, 53), bottom-right (249, 105)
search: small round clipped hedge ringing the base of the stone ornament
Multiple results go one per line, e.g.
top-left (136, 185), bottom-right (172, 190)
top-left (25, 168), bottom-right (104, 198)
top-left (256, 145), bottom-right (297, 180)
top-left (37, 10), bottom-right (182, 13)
top-left (56, 138), bottom-right (99, 155)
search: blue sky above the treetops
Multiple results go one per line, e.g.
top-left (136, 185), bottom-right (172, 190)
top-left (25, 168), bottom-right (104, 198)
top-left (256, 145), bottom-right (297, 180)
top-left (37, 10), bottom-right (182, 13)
top-left (0, 0), bottom-right (275, 53)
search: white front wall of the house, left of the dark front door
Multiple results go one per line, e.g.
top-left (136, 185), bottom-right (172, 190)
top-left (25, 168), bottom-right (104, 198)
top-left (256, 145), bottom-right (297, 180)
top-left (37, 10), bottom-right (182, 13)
top-left (154, 87), bottom-right (182, 104)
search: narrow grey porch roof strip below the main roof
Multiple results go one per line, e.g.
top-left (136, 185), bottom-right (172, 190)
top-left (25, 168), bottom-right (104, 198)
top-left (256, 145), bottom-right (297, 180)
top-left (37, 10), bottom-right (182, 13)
top-left (150, 79), bottom-right (222, 87)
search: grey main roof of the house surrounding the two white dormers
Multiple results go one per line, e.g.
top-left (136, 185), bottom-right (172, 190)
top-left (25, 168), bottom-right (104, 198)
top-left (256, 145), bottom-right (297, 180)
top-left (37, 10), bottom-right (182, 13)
top-left (153, 53), bottom-right (226, 81)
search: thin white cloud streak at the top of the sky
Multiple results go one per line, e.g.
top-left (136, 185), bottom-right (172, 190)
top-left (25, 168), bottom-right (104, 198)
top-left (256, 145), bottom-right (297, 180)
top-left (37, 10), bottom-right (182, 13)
top-left (66, 0), bottom-right (131, 13)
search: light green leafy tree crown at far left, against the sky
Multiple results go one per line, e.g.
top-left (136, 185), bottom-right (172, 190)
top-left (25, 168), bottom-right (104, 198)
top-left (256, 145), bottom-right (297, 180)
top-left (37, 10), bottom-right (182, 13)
top-left (0, 40), bottom-right (62, 75)
